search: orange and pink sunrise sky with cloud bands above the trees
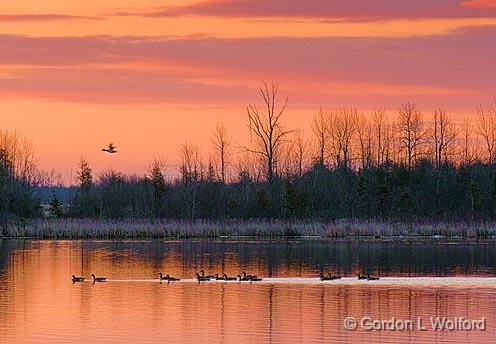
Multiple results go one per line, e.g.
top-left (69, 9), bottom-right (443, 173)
top-left (0, 0), bottom-right (496, 179)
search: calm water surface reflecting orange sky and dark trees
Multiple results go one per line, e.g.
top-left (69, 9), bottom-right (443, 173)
top-left (0, 240), bottom-right (496, 343)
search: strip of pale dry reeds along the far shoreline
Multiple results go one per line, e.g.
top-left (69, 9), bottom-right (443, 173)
top-left (0, 219), bottom-right (496, 239)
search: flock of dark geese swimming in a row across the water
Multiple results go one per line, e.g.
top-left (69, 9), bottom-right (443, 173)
top-left (72, 270), bottom-right (379, 284)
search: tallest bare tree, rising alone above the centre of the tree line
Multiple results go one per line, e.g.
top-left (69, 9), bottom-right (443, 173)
top-left (245, 82), bottom-right (291, 183)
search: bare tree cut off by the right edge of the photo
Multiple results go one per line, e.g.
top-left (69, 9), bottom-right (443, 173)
top-left (475, 101), bottom-right (496, 164)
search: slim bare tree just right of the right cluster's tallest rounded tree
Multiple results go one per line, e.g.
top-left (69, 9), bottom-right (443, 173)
top-left (431, 109), bottom-right (458, 167)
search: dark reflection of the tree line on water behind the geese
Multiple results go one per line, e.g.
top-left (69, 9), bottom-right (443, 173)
top-left (48, 240), bottom-right (496, 277)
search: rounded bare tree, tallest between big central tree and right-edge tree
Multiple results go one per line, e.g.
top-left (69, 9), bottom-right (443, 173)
top-left (396, 103), bottom-right (425, 168)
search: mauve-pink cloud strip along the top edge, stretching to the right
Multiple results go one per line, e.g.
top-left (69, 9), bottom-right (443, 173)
top-left (125, 0), bottom-right (496, 21)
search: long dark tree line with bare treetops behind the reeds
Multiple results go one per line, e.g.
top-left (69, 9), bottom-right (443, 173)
top-left (0, 83), bottom-right (496, 221)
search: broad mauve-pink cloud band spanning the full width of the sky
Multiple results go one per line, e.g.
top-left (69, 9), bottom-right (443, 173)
top-left (0, 27), bottom-right (496, 107)
